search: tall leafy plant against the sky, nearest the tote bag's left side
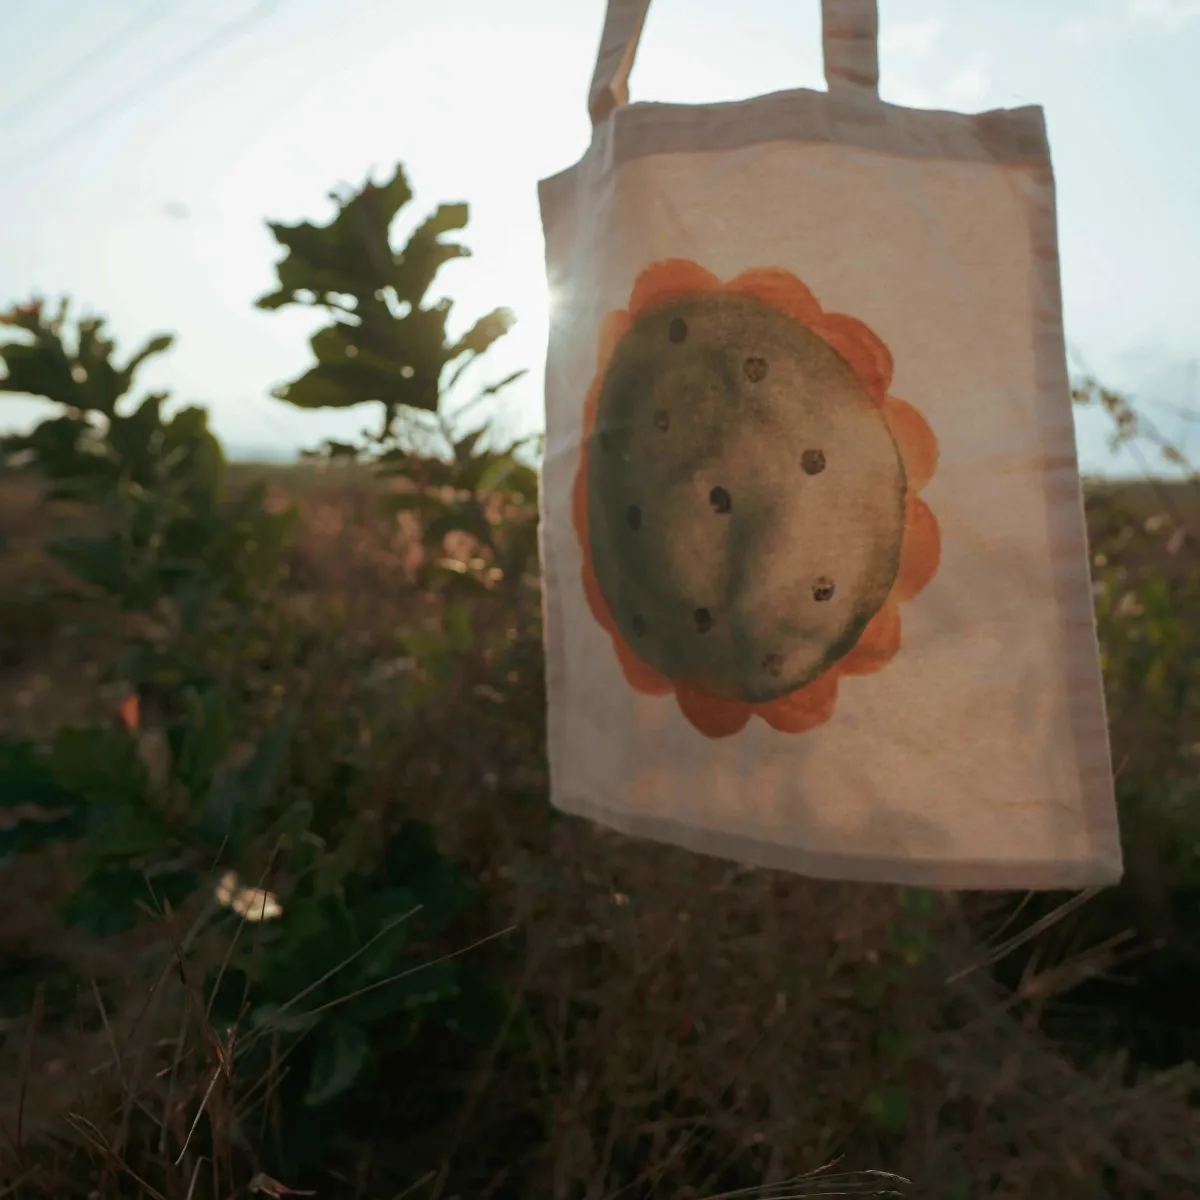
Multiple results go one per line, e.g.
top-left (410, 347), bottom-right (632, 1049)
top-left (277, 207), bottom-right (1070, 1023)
top-left (265, 166), bottom-right (538, 632)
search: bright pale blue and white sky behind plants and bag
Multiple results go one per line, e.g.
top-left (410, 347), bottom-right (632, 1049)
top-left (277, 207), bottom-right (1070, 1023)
top-left (0, 0), bottom-right (1200, 473)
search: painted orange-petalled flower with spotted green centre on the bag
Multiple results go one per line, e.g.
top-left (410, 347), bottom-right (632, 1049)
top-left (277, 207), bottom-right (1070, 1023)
top-left (572, 259), bottom-right (941, 738)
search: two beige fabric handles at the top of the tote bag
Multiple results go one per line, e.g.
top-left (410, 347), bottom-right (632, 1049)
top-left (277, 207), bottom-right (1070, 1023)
top-left (588, 0), bottom-right (880, 125)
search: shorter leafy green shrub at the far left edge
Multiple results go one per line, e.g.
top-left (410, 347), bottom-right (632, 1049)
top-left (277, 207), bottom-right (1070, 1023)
top-left (0, 301), bottom-right (296, 688)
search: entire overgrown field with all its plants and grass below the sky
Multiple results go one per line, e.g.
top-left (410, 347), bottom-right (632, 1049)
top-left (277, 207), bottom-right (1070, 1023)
top-left (0, 167), bottom-right (1200, 1200)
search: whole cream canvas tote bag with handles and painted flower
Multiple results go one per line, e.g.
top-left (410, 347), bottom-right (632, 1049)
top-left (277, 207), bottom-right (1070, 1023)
top-left (540, 0), bottom-right (1121, 888)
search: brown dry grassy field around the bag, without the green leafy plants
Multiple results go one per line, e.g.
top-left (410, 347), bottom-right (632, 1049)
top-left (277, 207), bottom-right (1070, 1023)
top-left (0, 467), bottom-right (1200, 1200)
